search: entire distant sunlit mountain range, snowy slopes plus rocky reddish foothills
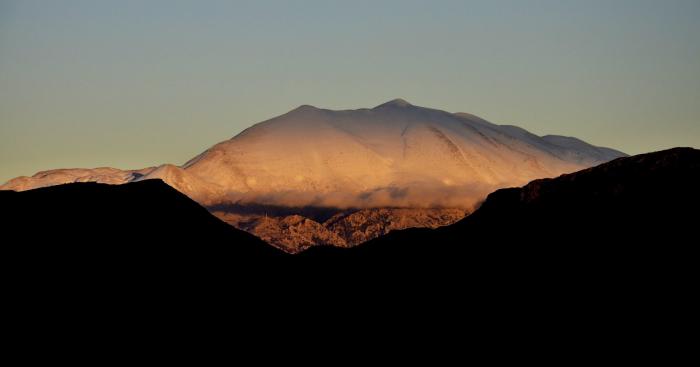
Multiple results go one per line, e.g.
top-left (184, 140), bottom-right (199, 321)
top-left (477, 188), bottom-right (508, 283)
top-left (0, 99), bottom-right (625, 252)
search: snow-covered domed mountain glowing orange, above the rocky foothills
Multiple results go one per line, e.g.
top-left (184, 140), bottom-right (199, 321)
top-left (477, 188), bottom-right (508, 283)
top-left (183, 100), bottom-right (624, 208)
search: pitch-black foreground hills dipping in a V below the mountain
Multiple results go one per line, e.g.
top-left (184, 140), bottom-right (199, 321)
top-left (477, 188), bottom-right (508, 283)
top-left (0, 148), bottom-right (700, 354)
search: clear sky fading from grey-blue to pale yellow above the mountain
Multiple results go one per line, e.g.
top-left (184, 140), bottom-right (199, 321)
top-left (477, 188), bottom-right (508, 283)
top-left (0, 0), bottom-right (700, 182)
